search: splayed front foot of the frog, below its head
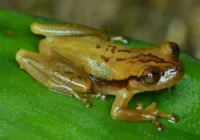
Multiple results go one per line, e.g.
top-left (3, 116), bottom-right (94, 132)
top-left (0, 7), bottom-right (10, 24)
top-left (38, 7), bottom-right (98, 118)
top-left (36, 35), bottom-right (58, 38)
top-left (142, 102), bottom-right (177, 131)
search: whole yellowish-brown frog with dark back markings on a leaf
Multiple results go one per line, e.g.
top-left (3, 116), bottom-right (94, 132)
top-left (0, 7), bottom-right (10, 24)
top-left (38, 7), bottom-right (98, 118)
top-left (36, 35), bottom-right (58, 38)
top-left (16, 22), bottom-right (184, 131)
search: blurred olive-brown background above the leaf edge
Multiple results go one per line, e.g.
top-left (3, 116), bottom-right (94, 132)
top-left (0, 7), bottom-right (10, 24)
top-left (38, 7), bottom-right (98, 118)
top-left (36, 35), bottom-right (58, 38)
top-left (0, 0), bottom-right (200, 58)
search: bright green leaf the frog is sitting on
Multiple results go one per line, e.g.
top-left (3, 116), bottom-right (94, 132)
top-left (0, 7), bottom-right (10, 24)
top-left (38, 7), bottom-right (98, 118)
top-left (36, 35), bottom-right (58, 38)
top-left (0, 10), bottom-right (200, 140)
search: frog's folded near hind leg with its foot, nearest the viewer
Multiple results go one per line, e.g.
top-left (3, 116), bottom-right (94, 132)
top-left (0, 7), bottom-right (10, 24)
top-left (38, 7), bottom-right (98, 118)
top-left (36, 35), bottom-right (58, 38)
top-left (16, 50), bottom-right (106, 107)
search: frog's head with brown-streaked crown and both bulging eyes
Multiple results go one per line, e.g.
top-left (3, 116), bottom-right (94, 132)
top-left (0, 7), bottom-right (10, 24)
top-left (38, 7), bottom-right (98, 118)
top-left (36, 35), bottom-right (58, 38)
top-left (129, 42), bottom-right (184, 92)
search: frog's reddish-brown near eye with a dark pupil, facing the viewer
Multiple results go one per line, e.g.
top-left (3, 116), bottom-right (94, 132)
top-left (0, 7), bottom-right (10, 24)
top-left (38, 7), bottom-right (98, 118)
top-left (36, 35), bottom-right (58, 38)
top-left (141, 67), bottom-right (160, 85)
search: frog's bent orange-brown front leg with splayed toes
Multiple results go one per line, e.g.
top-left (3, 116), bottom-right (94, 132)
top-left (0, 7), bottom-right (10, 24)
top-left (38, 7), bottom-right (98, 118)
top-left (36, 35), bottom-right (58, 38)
top-left (111, 90), bottom-right (176, 131)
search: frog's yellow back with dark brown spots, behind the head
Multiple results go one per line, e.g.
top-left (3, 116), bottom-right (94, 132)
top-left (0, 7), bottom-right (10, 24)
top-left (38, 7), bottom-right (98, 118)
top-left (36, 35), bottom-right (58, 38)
top-left (51, 36), bottom-right (165, 80)
